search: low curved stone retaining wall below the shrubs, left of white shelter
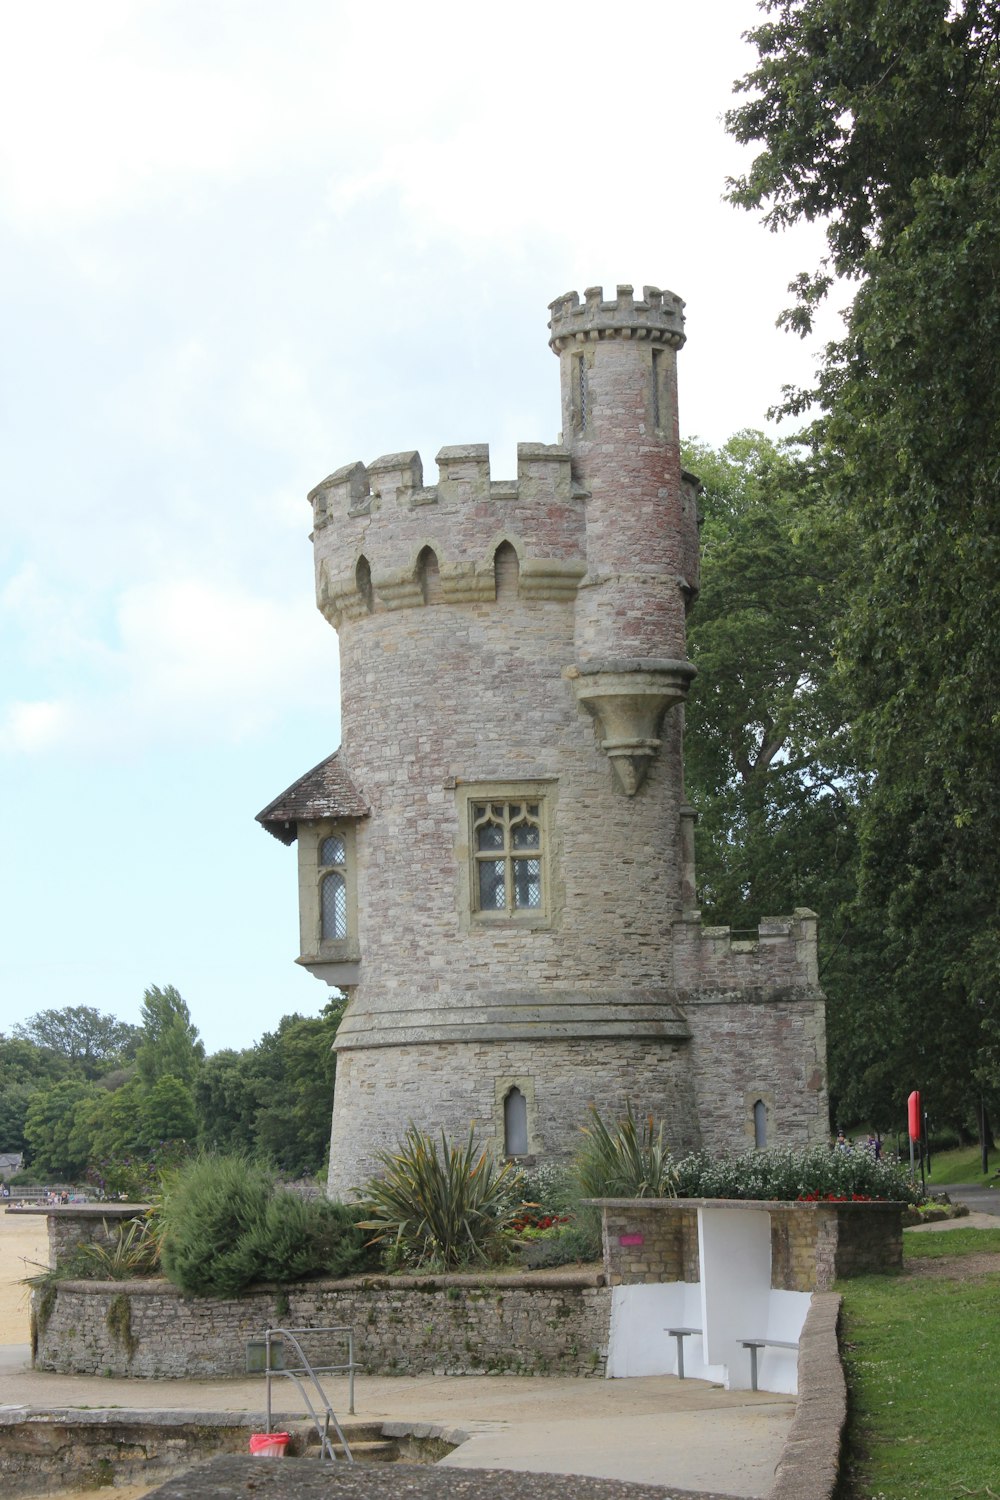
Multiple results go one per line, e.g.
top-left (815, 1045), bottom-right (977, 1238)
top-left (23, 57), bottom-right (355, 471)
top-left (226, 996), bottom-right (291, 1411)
top-left (31, 1271), bottom-right (610, 1379)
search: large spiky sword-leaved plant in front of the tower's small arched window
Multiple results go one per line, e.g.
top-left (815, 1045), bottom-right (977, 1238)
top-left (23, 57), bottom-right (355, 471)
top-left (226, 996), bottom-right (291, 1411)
top-left (358, 1125), bottom-right (517, 1271)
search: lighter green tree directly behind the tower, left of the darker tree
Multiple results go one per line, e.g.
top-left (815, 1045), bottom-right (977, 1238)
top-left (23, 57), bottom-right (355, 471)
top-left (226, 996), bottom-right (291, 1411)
top-left (684, 432), bottom-right (856, 927)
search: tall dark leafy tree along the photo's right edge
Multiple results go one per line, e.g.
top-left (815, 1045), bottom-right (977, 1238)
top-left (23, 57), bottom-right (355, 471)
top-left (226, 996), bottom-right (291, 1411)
top-left (729, 0), bottom-right (1000, 1124)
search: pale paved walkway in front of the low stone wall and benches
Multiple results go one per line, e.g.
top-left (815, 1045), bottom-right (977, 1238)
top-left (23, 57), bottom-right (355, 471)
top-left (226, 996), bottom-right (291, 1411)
top-left (0, 1346), bottom-right (795, 1496)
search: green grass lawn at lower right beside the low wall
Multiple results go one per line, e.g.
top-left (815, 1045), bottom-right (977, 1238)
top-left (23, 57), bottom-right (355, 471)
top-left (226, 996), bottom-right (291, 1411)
top-left (838, 1229), bottom-right (1000, 1500)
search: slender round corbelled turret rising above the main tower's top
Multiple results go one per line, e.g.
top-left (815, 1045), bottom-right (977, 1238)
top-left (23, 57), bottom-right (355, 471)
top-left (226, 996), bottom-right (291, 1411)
top-left (549, 285), bottom-right (697, 797)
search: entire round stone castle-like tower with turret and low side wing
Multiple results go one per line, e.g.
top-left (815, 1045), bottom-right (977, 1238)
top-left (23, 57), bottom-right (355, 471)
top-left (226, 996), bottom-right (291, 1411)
top-left (258, 287), bottom-right (828, 1196)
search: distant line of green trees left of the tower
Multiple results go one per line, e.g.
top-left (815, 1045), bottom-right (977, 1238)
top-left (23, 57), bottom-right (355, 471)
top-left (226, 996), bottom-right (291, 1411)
top-left (0, 986), bottom-right (340, 1194)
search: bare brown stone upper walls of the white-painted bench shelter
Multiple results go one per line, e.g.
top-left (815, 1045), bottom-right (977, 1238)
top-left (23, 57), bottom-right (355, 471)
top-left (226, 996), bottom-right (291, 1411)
top-left (595, 1199), bottom-right (903, 1292)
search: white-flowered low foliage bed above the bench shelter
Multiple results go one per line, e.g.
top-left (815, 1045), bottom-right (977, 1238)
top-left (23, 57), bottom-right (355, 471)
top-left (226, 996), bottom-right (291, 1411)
top-left (676, 1146), bottom-right (921, 1203)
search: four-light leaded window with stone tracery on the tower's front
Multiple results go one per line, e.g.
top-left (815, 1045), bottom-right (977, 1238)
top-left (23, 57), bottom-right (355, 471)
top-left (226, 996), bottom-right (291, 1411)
top-left (471, 801), bottom-right (543, 914)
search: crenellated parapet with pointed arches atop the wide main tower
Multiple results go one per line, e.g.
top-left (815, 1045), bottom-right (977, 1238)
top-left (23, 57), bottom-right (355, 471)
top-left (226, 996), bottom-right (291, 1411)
top-left (309, 443), bottom-right (586, 629)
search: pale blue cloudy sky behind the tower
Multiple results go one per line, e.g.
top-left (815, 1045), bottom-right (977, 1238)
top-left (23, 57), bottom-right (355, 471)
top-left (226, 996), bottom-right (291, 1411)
top-left (0, 0), bottom-right (834, 1052)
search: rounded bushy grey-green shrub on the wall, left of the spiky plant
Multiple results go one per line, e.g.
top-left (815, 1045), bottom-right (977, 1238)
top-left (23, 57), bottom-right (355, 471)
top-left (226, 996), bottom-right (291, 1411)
top-left (159, 1155), bottom-right (363, 1298)
